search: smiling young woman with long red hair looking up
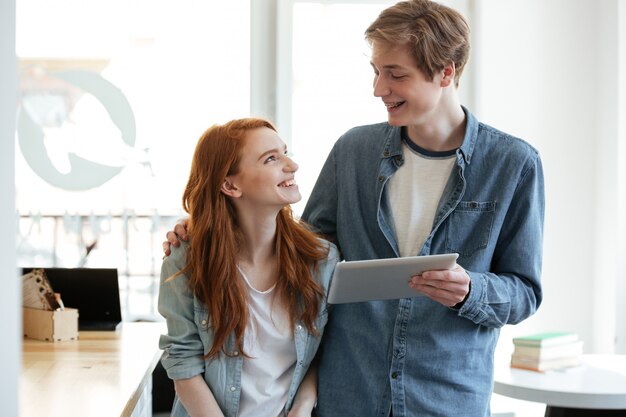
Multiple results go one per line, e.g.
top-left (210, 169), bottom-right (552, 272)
top-left (159, 118), bottom-right (338, 417)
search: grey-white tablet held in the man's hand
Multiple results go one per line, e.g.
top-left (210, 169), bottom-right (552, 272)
top-left (328, 253), bottom-right (459, 304)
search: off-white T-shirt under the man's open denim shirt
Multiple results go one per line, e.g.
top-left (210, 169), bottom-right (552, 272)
top-left (389, 141), bottom-right (455, 256)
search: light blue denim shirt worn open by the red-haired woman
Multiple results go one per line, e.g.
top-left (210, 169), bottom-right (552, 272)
top-left (158, 237), bottom-right (339, 417)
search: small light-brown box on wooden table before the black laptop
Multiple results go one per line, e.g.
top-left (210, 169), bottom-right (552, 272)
top-left (22, 308), bottom-right (78, 342)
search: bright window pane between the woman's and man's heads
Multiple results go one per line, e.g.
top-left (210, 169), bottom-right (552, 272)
top-left (277, 0), bottom-right (395, 214)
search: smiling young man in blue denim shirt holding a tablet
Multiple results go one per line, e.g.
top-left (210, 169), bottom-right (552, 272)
top-left (166, 0), bottom-right (544, 417)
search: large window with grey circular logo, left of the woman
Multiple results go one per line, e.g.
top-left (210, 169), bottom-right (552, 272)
top-left (15, 0), bottom-right (250, 319)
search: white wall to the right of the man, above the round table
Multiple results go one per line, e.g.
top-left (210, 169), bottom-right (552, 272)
top-left (471, 0), bottom-right (626, 352)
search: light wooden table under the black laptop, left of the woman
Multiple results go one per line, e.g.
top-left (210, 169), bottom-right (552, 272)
top-left (20, 323), bottom-right (165, 417)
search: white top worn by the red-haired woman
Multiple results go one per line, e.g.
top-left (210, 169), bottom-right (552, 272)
top-left (238, 269), bottom-right (296, 417)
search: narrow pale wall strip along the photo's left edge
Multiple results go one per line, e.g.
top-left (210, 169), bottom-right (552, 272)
top-left (0, 0), bottom-right (22, 416)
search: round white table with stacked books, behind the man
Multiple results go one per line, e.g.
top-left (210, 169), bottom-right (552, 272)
top-left (493, 355), bottom-right (626, 417)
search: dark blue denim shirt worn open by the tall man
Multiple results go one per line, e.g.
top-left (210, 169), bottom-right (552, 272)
top-left (302, 108), bottom-right (544, 417)
